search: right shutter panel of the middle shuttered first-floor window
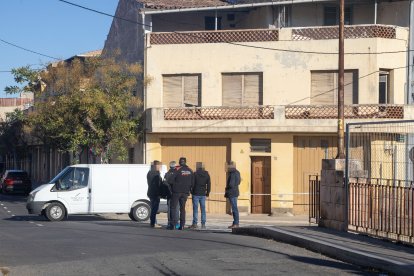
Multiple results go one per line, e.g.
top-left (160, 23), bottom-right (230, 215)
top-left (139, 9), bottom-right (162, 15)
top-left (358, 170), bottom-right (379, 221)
top-left (243, 74), bottom-right (263, 106)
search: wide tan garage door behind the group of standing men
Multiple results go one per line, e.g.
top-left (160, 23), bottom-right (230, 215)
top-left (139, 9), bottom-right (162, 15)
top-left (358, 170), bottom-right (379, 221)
top-left (161, 138), bottom-right (230, 214)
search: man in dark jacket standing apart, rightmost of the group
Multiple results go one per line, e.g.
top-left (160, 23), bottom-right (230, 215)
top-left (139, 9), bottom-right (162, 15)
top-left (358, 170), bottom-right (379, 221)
top-left (224, 161), bottom-right (241, 228)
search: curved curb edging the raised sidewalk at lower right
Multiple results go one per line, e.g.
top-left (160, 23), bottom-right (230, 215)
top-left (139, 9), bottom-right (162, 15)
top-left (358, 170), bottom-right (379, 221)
top-left (232, 227), bottom-right (414, 275)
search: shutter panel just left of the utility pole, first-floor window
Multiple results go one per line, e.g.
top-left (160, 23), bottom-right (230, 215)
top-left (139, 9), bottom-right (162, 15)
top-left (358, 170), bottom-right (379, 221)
top-left (310, 72), bottom-right (337, 105)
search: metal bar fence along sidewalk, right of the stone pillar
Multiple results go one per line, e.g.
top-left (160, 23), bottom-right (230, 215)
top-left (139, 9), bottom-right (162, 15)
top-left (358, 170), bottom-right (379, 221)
top-left (348, 178), bottom-right (414, 243)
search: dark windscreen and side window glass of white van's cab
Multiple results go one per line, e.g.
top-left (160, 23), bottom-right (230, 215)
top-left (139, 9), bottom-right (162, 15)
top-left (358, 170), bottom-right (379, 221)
top-left (53, 167), bottom-right (89, 191)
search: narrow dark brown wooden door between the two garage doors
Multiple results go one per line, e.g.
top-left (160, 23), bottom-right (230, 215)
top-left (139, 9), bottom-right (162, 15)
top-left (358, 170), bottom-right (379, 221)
top-left (251, 157), bottom-right (272, 214)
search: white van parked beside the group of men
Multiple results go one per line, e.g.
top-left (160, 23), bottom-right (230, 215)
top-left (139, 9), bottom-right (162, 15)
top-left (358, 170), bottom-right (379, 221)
top-left (26, 164), bottom-right (167, 221)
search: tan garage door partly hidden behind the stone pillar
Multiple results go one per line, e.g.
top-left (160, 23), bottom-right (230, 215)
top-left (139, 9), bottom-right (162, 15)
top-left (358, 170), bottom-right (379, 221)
top-left (293, 136), bottom-right (337, 215)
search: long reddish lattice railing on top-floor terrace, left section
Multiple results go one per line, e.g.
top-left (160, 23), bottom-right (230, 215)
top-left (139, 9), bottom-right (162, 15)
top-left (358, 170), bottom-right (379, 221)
top-left (150, 29), bottom-right (279, 44)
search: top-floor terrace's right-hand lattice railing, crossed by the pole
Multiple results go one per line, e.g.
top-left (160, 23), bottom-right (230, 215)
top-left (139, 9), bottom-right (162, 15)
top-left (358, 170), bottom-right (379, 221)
top-left (292, 25), bottom-right (397, 40)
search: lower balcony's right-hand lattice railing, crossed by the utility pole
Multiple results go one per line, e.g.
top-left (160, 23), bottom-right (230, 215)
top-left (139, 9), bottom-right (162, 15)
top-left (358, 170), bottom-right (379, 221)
top-left (285, 104), bottom-right (404, 119)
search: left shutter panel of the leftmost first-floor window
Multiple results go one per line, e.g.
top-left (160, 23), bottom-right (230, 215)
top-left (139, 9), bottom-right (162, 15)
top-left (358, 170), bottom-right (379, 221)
top-left (163, 76), bottom-right (183, 107)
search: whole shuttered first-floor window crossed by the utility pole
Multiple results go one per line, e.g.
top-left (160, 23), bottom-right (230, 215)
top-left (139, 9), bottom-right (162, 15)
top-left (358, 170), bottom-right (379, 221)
top-left (310, 70), bottom-right (358, 105)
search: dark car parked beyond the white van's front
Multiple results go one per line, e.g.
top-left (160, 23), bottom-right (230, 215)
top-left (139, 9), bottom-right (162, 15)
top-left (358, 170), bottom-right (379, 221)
top-left (0, 170), bottom-right (32, 194)
